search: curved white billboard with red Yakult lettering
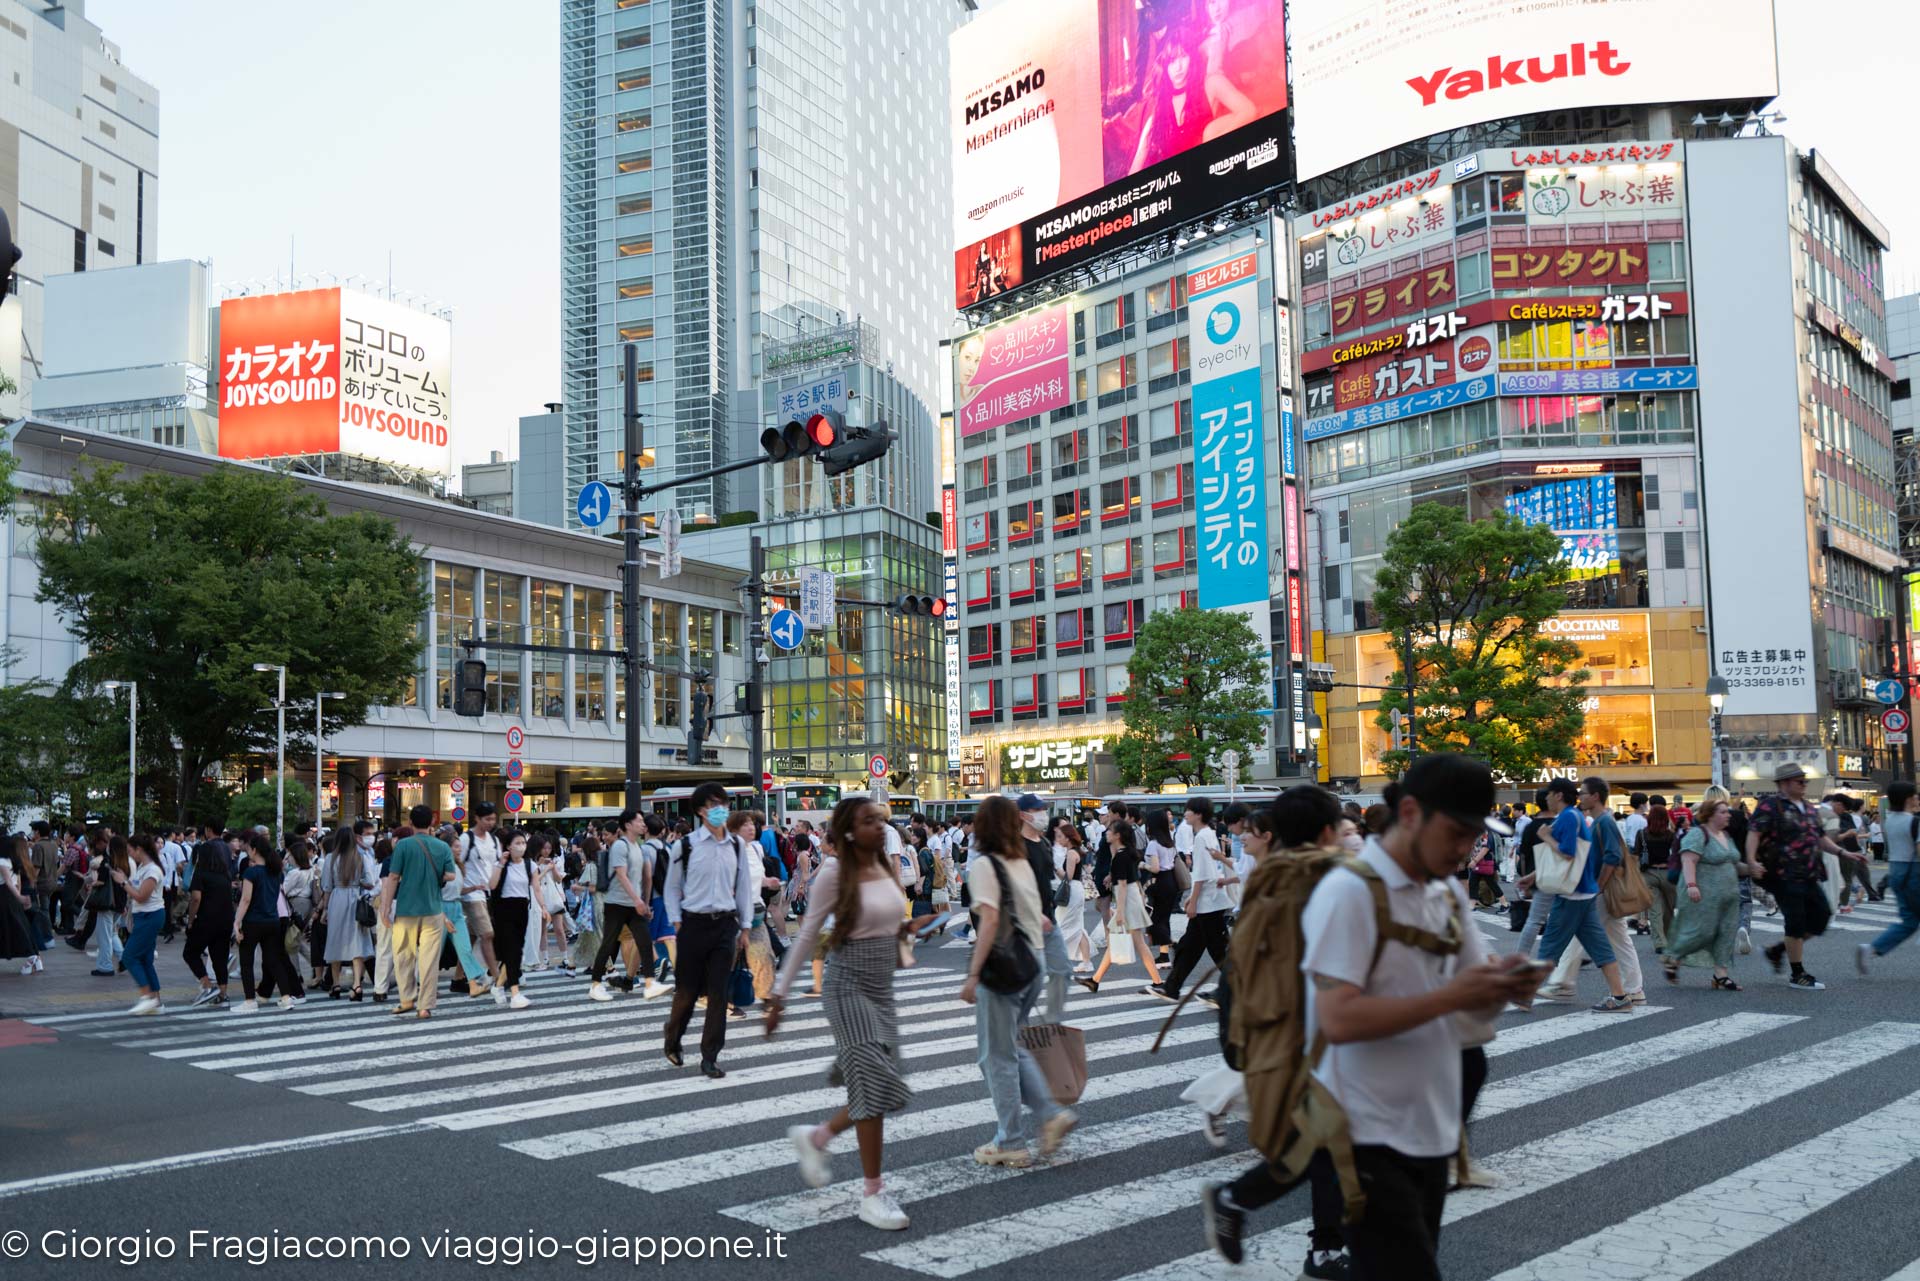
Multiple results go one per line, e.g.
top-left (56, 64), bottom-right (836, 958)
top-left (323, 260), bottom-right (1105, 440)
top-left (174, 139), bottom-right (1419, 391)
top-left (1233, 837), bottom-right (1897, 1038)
top-left (1290, 0), bottom-right (1780, 179)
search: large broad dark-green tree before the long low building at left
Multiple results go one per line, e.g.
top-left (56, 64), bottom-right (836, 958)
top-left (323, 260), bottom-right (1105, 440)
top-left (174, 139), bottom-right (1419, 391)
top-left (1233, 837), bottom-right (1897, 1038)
top-left (36, 467), bottom-right (426, 820)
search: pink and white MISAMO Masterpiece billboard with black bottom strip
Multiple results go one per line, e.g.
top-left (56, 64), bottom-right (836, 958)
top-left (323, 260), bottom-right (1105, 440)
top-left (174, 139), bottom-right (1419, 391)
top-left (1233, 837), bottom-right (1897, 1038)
top-left (950, 0), bottom-right (1292, 307)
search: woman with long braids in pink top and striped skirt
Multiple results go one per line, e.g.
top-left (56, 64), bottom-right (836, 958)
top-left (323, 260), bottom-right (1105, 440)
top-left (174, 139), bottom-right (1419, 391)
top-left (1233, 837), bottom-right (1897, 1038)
top-left (766, 797), bottom-right (912, 1231)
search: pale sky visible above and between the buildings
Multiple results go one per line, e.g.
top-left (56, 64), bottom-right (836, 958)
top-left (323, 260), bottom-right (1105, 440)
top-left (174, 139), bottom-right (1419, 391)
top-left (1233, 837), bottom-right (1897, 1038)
top-left (86, 0), bottom-right (1920, 476)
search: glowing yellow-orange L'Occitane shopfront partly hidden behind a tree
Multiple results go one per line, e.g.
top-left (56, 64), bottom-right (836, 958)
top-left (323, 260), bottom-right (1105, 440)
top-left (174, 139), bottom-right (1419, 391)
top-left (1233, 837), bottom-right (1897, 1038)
top-left (1321, 609), bottom-right (1713, 795)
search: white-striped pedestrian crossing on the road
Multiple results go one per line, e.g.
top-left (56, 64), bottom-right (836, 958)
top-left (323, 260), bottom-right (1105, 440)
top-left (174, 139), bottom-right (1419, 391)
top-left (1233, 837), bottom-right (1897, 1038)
top-left (22, 941), bottom-right (1920, 1281)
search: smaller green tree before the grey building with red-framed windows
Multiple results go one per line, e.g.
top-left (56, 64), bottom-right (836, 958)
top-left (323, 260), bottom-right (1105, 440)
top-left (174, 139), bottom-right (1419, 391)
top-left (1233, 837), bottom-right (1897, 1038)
top-left (1114, 609), bottom-right (1269, 786)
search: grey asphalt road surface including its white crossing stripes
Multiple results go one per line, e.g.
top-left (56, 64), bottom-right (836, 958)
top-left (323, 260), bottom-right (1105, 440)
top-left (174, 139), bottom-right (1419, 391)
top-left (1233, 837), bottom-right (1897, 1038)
top-left (0, 908), bottom-right (1920, 1281)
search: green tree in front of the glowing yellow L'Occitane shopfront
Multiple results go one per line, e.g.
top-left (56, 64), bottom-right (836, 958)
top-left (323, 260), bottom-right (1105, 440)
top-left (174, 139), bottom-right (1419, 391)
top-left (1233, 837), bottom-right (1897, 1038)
top-left (1373, 503), bottom-right (1588, 782)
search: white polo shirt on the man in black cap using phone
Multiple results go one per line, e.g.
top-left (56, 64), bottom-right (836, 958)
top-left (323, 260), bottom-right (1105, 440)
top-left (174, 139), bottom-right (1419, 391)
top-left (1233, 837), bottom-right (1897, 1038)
top-left (1300, 837), bottom-right (1486, 1156)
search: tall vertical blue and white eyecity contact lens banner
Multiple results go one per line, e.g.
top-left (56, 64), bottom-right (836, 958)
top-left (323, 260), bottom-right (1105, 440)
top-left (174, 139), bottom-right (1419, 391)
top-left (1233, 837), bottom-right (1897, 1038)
top-left (1187, 252), bottom-right (1269, 626)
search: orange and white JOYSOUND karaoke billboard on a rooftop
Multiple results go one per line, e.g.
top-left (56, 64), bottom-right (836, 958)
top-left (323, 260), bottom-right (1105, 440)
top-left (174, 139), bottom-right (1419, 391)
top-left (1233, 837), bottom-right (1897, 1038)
top-left (219, 288), bottom-right (453, 474)
